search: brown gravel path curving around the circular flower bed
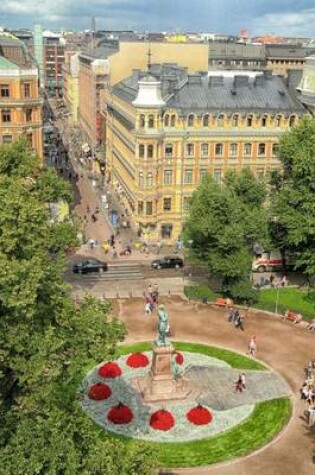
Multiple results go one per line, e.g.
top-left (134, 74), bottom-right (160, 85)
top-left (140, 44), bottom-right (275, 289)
top-left (119, 298), bottom-right (315, 475)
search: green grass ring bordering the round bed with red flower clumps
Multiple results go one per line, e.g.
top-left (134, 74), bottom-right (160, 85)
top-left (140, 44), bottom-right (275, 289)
top-left (95, 342), bottom-right (292, 467)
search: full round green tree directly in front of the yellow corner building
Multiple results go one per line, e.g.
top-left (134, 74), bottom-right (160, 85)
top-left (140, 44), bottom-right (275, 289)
top-left (184, 171), bottom-right (267, 299)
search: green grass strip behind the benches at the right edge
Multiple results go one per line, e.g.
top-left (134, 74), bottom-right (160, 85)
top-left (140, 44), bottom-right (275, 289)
top-left (254, 287), bottom-right (315, 320)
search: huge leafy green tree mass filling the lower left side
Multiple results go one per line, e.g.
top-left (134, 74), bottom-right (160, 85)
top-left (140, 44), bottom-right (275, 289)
top-left (0, 143), bottom-right (155, 475)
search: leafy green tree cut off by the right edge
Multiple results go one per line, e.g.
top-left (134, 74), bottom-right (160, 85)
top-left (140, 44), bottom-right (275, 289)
top-left (270, 117), bottom-right (315, 276)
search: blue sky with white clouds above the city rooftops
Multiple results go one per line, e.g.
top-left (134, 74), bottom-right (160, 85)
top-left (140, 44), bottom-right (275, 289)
top-left (0, 0), bottom-right (315, 37)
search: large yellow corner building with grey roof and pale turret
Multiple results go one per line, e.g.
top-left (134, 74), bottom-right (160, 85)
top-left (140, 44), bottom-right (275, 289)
top-left (103, 65), bottom-right (305, 242)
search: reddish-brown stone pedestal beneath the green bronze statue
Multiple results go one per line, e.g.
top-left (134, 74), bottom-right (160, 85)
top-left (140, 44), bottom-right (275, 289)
top-left (138, 343), bottom-right (191, 403)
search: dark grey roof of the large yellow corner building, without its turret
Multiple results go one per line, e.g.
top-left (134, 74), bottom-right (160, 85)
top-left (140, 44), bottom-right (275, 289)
top-left (113, 65), bottom-right (305, 115)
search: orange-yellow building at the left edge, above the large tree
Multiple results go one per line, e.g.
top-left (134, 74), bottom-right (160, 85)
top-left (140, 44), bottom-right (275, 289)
top-left (0, 56), bottom-right (43, 158)
